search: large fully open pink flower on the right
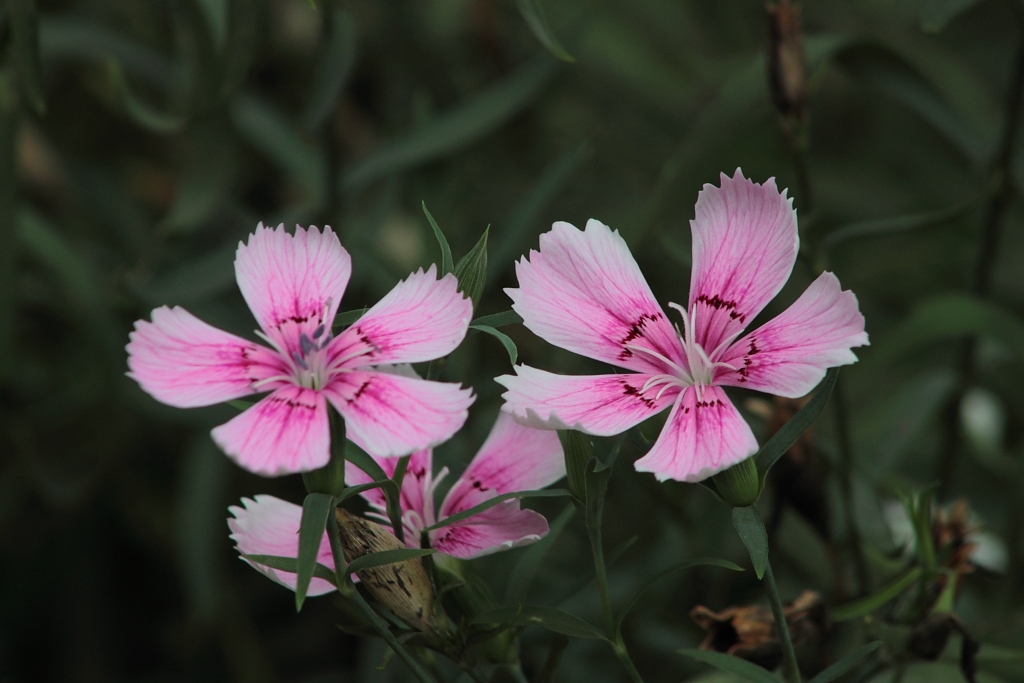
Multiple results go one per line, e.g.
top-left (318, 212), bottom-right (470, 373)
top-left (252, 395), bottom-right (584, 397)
top-left (498, 170), bottom-right (867, 481)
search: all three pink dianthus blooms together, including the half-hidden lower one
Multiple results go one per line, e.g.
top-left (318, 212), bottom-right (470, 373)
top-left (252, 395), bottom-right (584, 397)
top-left (127, 170), bottom-right (867, 595)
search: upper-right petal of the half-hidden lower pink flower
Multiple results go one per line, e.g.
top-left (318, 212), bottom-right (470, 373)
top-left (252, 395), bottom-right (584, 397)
top-left (440, 413), bottom-right (565, 520)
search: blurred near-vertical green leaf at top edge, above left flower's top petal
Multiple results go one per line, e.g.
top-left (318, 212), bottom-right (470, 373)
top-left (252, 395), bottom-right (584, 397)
top-left (302, 6), bottom-right (356, 131)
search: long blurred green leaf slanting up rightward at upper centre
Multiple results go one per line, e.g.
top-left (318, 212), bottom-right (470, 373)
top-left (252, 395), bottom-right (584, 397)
top-left (342, 57), bottom-right (558, 190)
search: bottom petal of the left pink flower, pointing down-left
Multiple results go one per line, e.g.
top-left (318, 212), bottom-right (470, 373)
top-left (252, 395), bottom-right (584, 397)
top-left (211, 384), bottom-right (331, 476)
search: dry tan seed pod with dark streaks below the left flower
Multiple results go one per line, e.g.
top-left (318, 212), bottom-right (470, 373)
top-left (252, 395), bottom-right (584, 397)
top-left (335, 508), bottom-right (437, 633)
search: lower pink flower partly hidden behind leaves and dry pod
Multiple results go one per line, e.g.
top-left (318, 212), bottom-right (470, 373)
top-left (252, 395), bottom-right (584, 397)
top-left (227, 414), bottom-right (565, 595)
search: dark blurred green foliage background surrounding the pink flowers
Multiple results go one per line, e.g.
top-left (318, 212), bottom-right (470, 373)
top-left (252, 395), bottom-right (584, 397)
top-left (0, 0), bottom-right (1024, 683)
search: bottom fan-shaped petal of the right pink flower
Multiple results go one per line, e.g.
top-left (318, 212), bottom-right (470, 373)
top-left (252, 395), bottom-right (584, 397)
top-left (634, 386), bottom-right (758, 481)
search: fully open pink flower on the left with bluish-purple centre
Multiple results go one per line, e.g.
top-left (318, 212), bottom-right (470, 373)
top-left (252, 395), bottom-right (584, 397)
top-left (127, 223), bottom-right (473, 476)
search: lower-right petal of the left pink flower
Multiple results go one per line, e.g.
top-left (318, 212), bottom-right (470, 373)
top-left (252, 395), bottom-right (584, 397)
top-left (325, 370), bottom-right (475, 458)
